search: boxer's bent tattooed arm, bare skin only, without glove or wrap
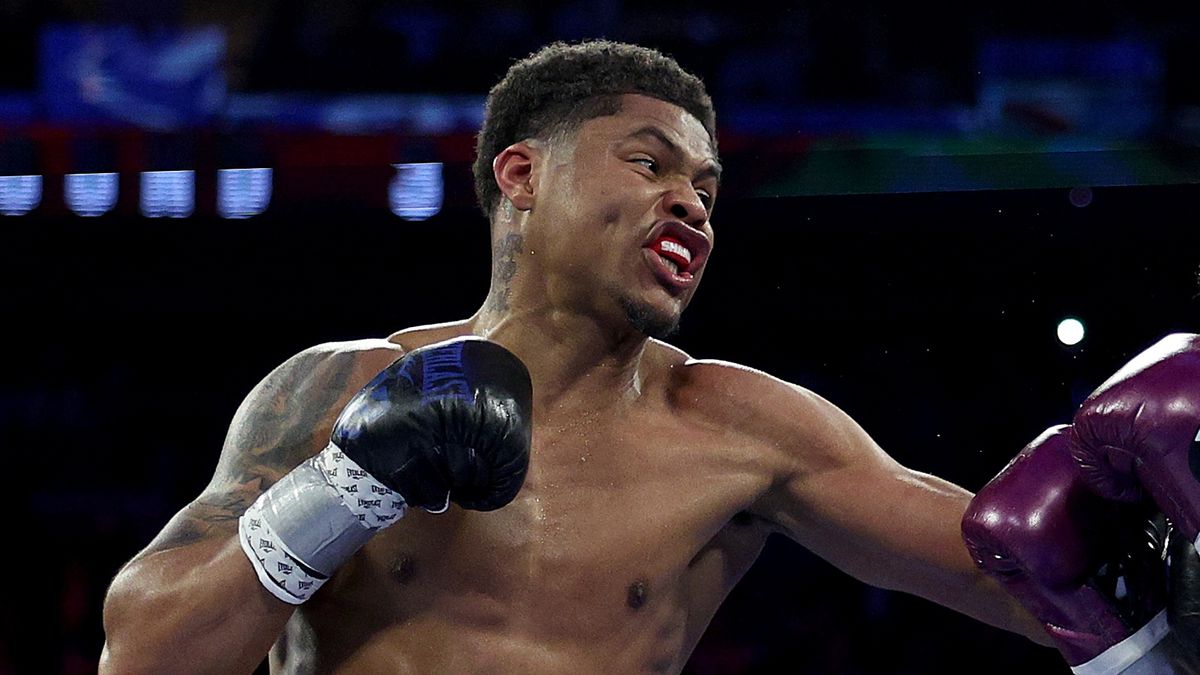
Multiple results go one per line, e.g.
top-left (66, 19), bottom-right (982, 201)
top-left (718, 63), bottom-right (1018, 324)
top-left (101, 342), bottom-right (401, 673)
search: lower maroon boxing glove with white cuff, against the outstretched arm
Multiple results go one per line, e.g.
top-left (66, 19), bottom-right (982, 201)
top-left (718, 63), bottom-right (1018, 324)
top-left (962, 426), bottom-right (1187, 674)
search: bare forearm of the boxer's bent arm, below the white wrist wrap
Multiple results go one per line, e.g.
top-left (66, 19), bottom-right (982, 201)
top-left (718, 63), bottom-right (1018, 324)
top-left (100, 533), bottom-right (295, 673)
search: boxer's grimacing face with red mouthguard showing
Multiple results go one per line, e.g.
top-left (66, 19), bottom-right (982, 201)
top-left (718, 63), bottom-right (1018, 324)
top-left (530, 95), bottom-right (720, 338)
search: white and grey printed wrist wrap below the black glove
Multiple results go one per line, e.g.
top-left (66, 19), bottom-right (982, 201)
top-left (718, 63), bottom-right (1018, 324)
top-left (238, 443), bottom-right (408, 604)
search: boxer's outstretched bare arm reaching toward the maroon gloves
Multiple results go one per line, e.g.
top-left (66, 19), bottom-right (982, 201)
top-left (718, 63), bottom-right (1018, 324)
top-left (756, 372), bottom-right (1049, 644)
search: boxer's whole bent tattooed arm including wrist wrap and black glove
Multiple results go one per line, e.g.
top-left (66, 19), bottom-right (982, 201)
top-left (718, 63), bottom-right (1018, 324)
top-left (102, 338), bottom-right (533, 673)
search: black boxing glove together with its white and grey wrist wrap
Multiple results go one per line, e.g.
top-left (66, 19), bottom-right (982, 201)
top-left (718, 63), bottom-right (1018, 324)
top-left (238, 338), bottom-right (533, 604)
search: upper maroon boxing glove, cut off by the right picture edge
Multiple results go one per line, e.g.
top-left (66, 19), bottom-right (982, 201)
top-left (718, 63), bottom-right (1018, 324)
top-left (1070, 334), bottom-right (1200, 548)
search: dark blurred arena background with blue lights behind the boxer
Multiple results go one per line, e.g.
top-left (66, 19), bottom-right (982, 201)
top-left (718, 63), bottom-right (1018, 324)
top-left (0, 0), bottom-right (1200, 675)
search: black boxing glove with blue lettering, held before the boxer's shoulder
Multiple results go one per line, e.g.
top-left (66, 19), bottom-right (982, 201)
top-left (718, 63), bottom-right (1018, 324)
top-left (331, 339), bottom-right (533, 510)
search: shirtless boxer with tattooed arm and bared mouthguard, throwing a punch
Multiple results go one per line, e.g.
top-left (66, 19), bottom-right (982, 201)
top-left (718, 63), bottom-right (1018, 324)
top-left (101, 43), bottom-right (1180, 675)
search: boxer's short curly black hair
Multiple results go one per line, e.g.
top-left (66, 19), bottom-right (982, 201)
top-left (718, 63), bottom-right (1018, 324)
top-left (473, 40), bottom-right (716, 219)
